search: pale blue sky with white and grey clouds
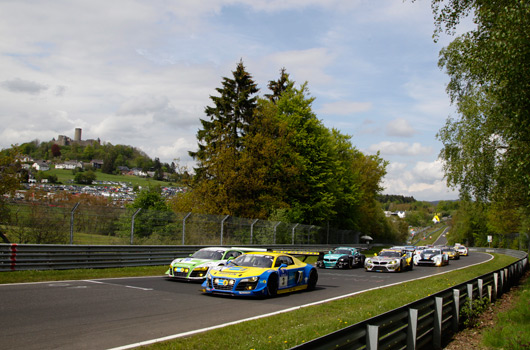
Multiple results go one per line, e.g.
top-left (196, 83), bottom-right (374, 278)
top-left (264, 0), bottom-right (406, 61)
top-left (0, 0), bottom-right (464, 201)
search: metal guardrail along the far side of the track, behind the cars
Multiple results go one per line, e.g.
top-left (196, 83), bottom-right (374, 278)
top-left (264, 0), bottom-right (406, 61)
top-left (0, 244), bottom-right (348, 272)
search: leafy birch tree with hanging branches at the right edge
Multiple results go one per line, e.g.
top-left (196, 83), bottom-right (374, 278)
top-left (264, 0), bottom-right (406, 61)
top-left (432, 0), bottom-right (530, 206)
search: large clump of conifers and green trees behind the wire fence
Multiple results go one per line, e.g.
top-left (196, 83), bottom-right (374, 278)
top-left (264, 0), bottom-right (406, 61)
top-left (171, 62), bottom-right (406, 243)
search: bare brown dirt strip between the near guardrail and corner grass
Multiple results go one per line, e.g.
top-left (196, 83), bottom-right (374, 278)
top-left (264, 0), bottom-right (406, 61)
top-left (444, 271), bottom-right (529, 350)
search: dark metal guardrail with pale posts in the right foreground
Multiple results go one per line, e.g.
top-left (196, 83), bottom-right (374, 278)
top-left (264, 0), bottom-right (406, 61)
top-left (291, 248), bottom-right (528, 350)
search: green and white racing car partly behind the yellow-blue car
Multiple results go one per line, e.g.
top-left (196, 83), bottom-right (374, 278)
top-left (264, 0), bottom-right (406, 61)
top-left (166, 247), bottom-right (266, 282)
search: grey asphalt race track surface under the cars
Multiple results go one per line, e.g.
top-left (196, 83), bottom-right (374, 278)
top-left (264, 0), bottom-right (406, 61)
top-left (0, 252), bottom-right (491, 350)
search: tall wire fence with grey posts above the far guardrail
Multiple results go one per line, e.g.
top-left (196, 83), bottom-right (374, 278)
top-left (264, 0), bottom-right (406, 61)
top-left (0, 202), bottom-right (366, 245)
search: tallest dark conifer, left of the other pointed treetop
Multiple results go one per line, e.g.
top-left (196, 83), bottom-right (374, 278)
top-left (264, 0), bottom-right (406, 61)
top-left (190, 61), bottom-right (259, 215)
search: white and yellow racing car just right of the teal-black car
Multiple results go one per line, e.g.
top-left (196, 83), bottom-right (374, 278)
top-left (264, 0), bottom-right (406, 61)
top-left (364, 249), bottom-right (413, 272)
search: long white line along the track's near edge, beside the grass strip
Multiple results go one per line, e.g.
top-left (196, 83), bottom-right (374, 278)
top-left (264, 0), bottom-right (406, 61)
top-left (108, 254), bottom-right (493, 350)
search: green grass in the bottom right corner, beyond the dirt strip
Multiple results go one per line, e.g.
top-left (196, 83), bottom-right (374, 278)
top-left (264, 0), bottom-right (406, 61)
top-left (482, 272), bottom-right (530, 350)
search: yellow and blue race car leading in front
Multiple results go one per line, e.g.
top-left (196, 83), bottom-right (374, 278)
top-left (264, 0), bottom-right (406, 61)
top-left (202, 252), bottom-right (318, 297)
